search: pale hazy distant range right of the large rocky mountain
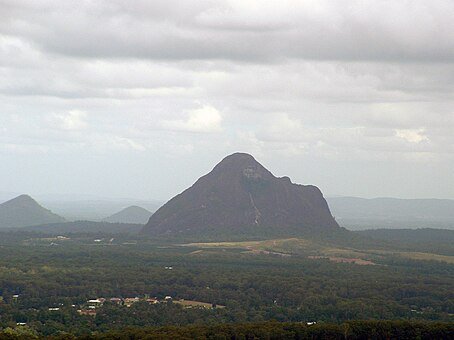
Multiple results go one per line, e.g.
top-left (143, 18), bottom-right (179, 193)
top-left (327, 197), bottom-right (454, 230)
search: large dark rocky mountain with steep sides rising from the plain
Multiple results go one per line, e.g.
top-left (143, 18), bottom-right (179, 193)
top-left (143, 153), bottom-right (341, 237)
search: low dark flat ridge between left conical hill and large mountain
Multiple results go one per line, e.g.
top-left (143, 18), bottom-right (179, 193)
top-left (21, 221), bottom-right (143, 235)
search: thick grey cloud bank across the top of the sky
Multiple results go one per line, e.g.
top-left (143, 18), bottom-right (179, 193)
top-left (0, 0), bottom-right (454, 62)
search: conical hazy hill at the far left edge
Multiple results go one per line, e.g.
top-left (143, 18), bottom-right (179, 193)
top-left (0, 195), bottom-right (65, 228)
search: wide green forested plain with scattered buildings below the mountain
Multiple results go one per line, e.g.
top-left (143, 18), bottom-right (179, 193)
top-left (0, 233), bottom-right (454, 338)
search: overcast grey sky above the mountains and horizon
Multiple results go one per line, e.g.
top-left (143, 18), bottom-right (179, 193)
top-left (0, 0), bottom-right (454, 199)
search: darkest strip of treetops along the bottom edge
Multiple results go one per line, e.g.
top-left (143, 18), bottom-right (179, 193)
top-left (37, 321), bottom-right (454, 340)
